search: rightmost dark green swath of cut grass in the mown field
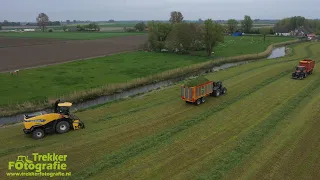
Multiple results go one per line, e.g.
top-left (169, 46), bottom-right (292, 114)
top-left (198, 72), bottom-right (320, 180)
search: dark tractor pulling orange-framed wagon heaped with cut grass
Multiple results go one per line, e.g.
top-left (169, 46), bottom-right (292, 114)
top-left (181, 77), bottom-right (227, 105)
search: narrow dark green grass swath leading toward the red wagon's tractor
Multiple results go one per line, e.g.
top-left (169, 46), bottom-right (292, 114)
top-left (70, 70), bottom-right (291, 179)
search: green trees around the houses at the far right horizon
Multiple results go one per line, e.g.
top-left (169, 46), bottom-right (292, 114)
top-left (274, 16), bottom-right (320, 33)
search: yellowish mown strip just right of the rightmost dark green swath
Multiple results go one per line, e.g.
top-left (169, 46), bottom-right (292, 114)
top-left (223, 88), bottom-right (320, 180)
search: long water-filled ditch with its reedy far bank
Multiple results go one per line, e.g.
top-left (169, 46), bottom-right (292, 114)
top-left (0, 40), bottom-right (303, 125)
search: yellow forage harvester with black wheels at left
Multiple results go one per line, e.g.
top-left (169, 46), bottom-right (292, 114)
top-left (23, 102), bottom-right (85, 139)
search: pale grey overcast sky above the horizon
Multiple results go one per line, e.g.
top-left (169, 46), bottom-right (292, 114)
top-left (0, 0), bottom-right (320, 21)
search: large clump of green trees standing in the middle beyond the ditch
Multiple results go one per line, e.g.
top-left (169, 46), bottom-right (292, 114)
top-left (148, 11), bottom-right (224, 56)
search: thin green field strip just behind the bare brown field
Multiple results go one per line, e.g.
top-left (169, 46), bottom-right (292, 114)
top-left (0, 32), bottom-right (144, 40)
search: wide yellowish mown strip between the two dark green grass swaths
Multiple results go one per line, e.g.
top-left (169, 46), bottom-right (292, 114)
top-left (102, 73), bottom-right (306, 179)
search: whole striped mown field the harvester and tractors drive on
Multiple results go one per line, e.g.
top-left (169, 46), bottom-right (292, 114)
top-left (0, 43), bottom-right (320, 180)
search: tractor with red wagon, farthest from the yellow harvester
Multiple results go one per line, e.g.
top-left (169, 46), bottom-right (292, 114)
top-left (292, 59), bottom-right (316, 79)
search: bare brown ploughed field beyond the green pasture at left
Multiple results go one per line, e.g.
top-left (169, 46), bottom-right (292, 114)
top-left (0, 35), bottom-right (147, 72)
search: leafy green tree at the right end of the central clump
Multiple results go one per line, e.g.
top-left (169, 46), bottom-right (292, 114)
top-left (202, 19), bottom-right (224, 57)
